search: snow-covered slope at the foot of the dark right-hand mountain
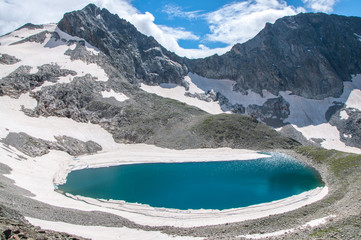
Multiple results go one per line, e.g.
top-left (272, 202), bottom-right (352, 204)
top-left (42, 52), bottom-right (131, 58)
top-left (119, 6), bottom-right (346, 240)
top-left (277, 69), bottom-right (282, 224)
top-left (141, 73), bottom-right (361, 153)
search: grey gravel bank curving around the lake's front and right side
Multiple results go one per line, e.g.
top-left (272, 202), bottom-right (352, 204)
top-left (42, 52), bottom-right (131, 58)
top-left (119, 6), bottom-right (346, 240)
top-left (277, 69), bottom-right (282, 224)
top-left (0, 147), bottom-right (361, 239)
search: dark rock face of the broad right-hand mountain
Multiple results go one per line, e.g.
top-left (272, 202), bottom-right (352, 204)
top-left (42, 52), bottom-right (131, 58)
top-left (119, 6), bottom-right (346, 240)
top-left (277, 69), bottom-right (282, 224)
top-left (187, 13), bottom-right (361, 99)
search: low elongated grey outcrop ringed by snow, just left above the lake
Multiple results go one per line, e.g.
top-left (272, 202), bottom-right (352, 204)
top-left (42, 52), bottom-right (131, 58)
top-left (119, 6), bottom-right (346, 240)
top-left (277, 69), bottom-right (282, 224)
top-left (1, 132), bottom-right (102, 157)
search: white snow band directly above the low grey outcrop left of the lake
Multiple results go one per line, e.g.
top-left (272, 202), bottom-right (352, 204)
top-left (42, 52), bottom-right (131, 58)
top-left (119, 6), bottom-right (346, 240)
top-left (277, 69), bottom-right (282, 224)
top-left (0, 94), bottom-right (118, 150)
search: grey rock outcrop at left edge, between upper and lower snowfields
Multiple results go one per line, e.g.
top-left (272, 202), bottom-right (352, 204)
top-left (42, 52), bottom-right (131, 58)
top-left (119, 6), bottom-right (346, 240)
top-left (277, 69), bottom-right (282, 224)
top-left (0, 64), bottom-right (76, 98)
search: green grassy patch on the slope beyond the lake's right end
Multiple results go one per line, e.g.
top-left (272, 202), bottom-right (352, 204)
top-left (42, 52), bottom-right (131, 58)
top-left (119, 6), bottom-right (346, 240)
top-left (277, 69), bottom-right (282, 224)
top-left (295, 146), bottom-right (361, 176)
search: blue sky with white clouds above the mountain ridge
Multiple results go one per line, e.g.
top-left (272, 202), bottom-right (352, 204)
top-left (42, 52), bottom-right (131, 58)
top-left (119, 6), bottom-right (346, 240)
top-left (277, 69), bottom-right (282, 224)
top-left (0, 0), bottom-right (361, 57)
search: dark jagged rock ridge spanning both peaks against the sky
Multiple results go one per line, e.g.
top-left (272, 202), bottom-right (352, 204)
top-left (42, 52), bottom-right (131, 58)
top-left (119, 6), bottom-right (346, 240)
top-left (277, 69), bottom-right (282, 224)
top-left (58, 4), bottom-right (361, 99)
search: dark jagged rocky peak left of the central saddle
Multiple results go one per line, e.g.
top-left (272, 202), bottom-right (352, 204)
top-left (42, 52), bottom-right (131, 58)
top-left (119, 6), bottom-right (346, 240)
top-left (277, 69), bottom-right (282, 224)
top-left (58, 4), bottom-right (188, 86)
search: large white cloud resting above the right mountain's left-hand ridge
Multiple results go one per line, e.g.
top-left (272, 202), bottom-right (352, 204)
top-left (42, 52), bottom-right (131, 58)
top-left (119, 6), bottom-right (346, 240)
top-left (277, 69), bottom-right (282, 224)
top-left (207, 0), bottom-right (305, 44)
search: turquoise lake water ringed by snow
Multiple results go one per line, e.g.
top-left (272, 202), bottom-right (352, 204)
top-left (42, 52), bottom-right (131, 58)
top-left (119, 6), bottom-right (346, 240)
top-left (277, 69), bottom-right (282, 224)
top-left (59, 154), bottom-right (323, 210)
